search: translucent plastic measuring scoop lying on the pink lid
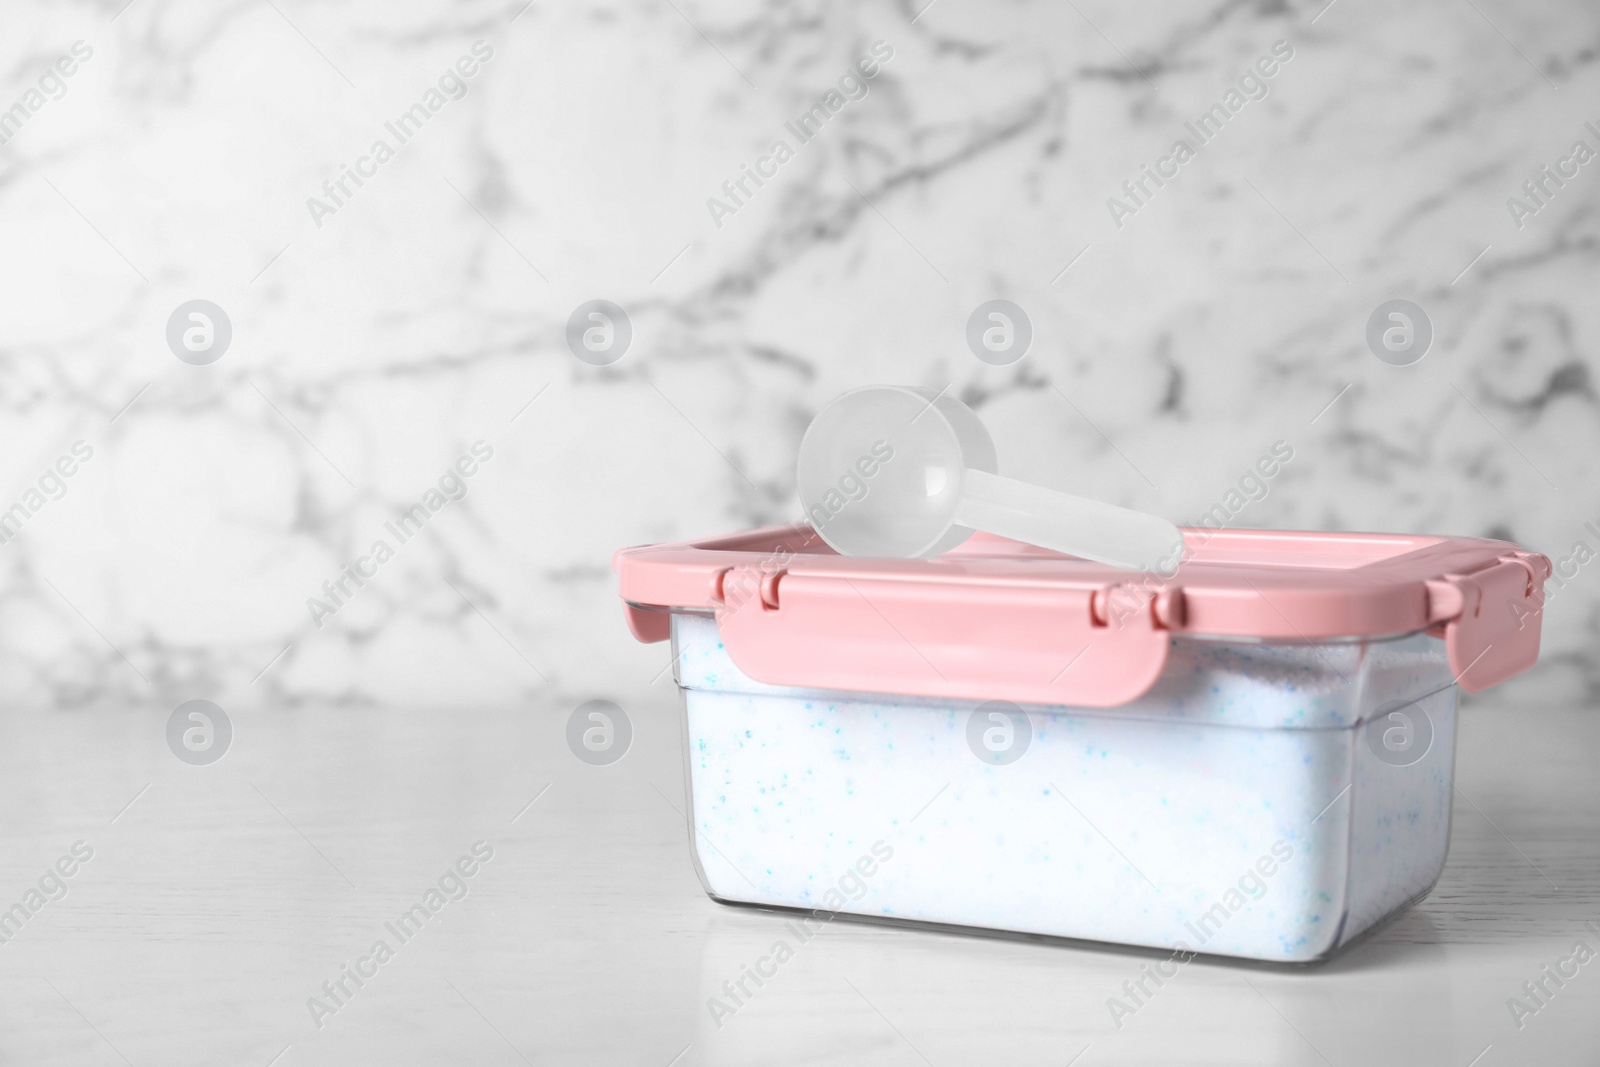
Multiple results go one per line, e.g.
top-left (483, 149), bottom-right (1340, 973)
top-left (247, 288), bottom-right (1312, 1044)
top-left (798, 386), bottom-right (1184, 573)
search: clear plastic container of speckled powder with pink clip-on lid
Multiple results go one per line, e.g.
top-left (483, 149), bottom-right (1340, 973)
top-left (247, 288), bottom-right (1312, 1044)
top-left (614, 526), bottom-right (1550, 963)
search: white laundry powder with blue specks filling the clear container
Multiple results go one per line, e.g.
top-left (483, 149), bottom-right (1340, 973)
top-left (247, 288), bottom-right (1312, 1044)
top-left (674, 614), bottom-right (1456, 961)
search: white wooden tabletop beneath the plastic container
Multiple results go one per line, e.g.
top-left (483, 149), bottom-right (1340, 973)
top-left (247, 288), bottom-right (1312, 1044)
top-left (0, 697), bottom-right (1600, 1067)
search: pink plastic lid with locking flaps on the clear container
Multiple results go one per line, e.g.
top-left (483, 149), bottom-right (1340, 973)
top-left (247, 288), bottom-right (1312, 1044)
top-left (613, 525), bottom-right (1550, 707)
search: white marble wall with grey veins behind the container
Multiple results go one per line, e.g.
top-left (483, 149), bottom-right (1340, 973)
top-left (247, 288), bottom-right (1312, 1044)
top-left (0, 0), bottom-right (1600, 707)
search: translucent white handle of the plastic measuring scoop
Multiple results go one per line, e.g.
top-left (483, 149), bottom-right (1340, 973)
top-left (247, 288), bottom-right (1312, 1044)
top-left (955, 467), bottom-right (1184, 571)
